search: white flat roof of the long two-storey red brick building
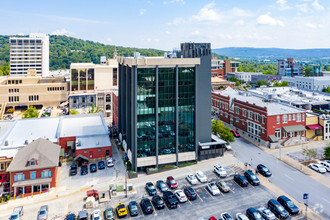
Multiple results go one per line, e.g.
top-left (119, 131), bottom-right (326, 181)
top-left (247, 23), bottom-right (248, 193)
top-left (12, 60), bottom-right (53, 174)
top-left (214, 87), bottom-right (305, 115)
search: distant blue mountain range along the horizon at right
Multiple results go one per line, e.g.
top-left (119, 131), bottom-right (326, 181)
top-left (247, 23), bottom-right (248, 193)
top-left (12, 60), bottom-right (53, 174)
top-left (212, 47), bottom-right (330, 59)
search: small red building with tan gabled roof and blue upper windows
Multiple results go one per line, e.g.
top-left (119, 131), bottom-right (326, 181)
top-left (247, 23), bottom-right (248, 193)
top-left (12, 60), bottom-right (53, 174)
top-left (7, 138), bottom-right (61, 197)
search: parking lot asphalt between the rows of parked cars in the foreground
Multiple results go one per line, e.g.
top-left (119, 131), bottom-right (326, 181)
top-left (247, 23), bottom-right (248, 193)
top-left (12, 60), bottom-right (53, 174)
top-left (89, 165), bottom-right (304, 219)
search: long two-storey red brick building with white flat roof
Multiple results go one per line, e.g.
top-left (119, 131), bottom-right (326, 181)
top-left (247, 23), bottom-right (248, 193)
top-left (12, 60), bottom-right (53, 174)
top-left (212, 88), bottom-right (306, 145)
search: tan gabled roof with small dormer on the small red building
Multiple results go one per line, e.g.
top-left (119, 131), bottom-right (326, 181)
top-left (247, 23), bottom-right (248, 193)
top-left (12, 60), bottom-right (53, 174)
top-left (7, 138), bottom-right (61, 172)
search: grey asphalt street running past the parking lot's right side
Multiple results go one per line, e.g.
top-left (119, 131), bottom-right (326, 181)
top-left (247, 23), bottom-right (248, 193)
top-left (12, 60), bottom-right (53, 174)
top-left (231, 138), bottom-right (330, 219)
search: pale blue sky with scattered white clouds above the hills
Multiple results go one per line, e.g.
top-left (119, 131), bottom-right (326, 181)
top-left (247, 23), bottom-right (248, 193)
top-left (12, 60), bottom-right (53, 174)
top-left (0, 0), bottom-right (330, 50)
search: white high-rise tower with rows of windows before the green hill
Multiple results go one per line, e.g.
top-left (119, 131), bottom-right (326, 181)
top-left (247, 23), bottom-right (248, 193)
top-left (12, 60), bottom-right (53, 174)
top-left (9, 33), bottom-right (49, 77)
